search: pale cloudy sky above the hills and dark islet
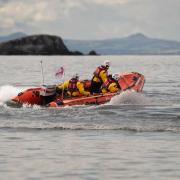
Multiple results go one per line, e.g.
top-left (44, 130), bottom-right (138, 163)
top-left (0, 0), bottom-right (180, 41)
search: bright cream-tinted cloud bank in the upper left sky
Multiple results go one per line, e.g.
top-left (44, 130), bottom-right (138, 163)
top-left (0, 0), bottom-right (130, 27)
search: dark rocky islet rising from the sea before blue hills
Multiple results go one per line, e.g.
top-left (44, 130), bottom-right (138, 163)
top-left (0, 35), bottom-right (82, 55)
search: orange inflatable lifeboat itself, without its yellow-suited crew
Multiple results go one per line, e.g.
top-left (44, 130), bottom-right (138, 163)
top-left (8, 72), bottom-right (145, 108)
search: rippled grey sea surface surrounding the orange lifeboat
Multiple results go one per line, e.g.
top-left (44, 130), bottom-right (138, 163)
top-left (0, 56), bottom-right (180, 180)
